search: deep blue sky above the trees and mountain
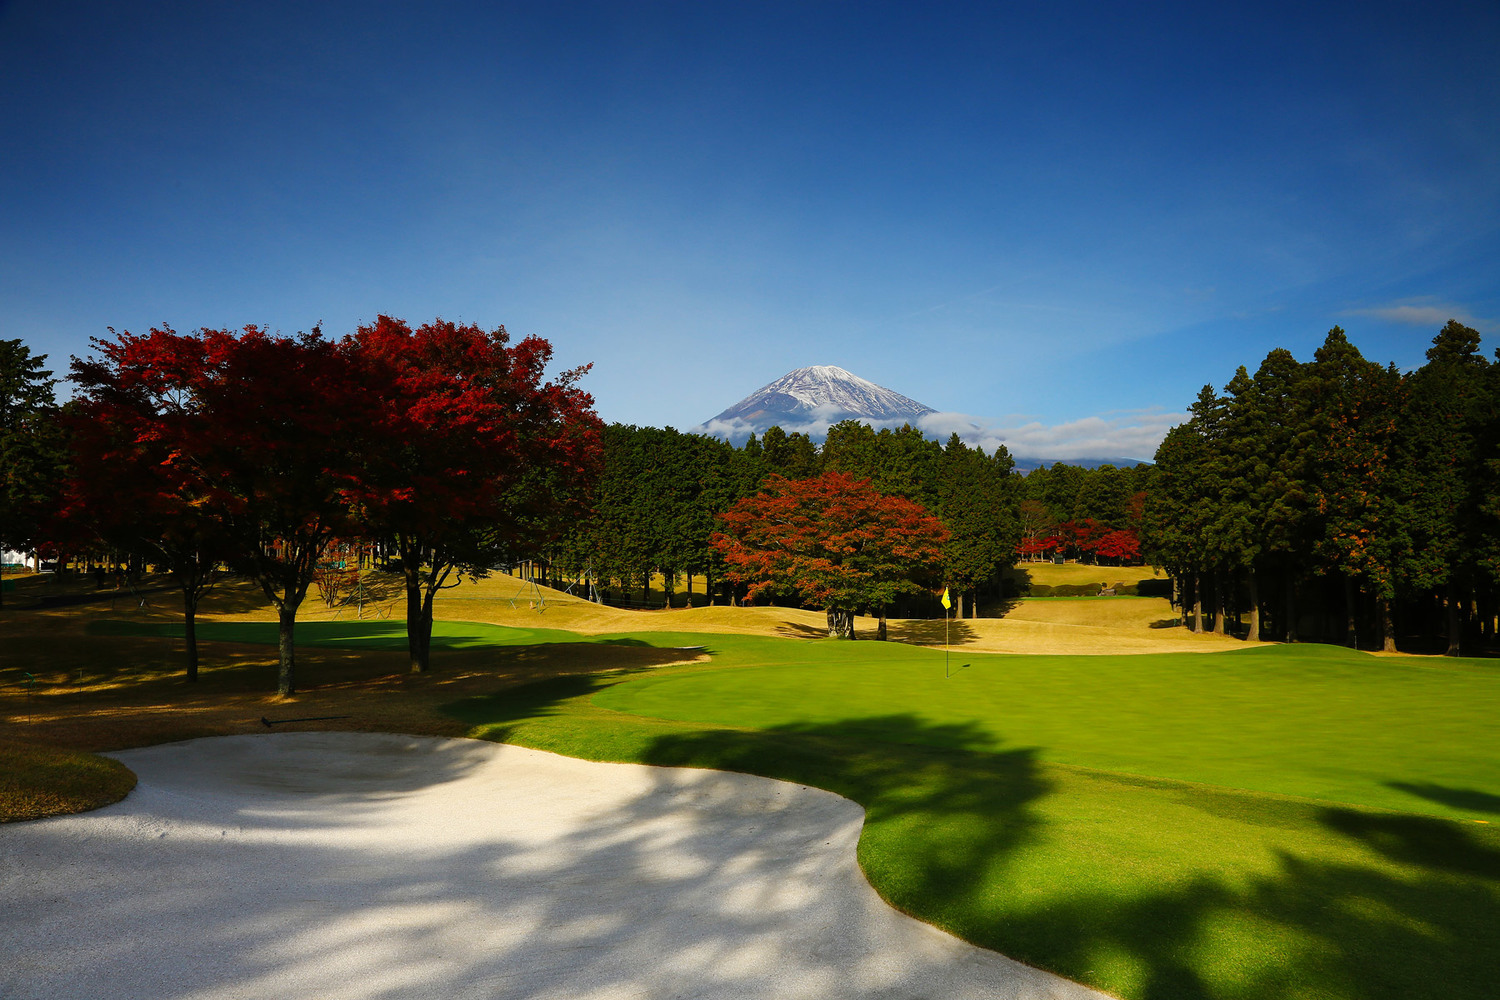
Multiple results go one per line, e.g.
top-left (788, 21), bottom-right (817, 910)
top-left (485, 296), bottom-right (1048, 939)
top-left (0, 0), bottom-right (1500, 457)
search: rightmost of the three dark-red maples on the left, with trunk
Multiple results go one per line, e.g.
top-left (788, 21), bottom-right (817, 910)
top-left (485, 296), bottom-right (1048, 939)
top-left (347, 316), bottom-right (602, 672)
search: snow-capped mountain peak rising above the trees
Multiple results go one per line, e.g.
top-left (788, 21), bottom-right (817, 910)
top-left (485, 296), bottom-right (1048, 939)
top-left (704, 364), bottom-right (938, 438)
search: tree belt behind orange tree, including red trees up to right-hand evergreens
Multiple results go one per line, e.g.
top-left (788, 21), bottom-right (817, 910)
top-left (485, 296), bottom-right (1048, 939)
top-left (552, 420), bottom-right (1152, 616)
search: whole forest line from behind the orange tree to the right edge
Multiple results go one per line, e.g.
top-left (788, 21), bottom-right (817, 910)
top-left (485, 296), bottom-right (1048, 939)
top-left (551, 321), bottom-right (1500, 655)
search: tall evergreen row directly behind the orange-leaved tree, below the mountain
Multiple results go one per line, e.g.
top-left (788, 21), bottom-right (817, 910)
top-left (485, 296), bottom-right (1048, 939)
top-left (554, 420), bottom-right (1020, 613)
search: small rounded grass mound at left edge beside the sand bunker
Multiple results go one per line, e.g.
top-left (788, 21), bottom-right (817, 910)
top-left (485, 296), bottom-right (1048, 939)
top-left (0, 739), bottom-right (135, 823)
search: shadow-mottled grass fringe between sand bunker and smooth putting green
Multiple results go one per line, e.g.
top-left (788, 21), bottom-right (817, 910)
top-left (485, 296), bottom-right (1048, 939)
top-left (444, 678), bottom-right (1500, 1000)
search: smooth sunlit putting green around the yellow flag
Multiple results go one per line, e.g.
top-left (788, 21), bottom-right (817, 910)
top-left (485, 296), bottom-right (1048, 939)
top-left (597, 637), bottom-right (1500, 819)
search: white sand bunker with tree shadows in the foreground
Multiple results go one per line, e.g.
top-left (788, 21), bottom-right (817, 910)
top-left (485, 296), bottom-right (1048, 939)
top-left (0, 733), bottom-right (1103, 1000)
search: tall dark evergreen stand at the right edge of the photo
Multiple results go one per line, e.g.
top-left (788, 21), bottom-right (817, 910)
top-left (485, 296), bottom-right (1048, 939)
top-left (1145, 321), bottom-right (1500, 655)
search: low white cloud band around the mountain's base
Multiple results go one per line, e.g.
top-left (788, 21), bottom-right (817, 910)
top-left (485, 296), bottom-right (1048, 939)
top-left (693, 409), bottom-right (1187, 462)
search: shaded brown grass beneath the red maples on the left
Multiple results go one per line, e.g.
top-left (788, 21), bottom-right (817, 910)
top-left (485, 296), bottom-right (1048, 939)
top-left (0, 586), bottom-right (701, 751)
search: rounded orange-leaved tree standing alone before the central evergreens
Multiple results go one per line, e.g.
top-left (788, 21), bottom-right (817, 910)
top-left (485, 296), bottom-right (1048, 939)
top-left (714, 472), bottom-right (948, 639)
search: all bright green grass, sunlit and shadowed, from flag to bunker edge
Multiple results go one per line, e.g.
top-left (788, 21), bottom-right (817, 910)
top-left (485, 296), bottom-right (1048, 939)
top-left (96, 622), bottom-right (1500, 1000)
